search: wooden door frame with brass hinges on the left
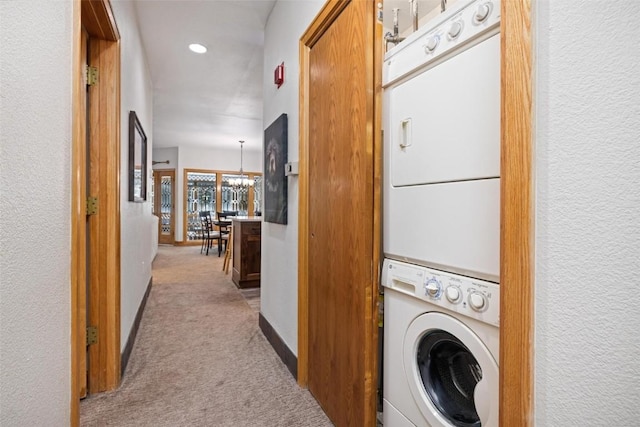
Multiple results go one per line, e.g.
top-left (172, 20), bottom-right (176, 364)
top-left (70, 0), bottom-right (120, 426)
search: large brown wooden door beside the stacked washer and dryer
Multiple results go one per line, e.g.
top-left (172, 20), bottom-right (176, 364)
top-left (299, 0), bottom-right (380, 426)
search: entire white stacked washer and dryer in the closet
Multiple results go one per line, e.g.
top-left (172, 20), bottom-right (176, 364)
top-left (381, 0), bottom-right (500, 427)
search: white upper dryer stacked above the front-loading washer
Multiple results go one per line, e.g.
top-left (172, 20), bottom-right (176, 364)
top-left (383, 0), bottom-right (500, 282)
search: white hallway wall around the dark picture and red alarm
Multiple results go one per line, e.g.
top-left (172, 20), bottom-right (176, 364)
top-left (260, 0), bottom-right (325, 354)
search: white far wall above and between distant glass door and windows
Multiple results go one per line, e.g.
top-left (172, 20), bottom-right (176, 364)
top-left (153, 143), bottom-right (262, 242)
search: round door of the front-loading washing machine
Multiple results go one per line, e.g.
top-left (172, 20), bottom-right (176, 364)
top-left (403, 312), bottom-right (499, 427)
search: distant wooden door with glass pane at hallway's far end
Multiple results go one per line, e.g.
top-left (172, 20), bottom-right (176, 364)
top-left (153, 169), bottom-right (176, 245)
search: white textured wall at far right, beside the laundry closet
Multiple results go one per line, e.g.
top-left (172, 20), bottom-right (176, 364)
top-left (534, 0), bottom-right (640, 426)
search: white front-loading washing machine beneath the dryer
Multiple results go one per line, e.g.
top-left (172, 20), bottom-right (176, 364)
top-left (382, 259), bottom-right (500, 427)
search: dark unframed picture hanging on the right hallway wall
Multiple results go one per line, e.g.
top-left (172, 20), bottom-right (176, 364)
top-left (263, 113), bottom-right (288, 224)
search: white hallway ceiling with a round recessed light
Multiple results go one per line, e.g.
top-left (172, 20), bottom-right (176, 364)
top-left (135, 0), bottom-right (276, 154)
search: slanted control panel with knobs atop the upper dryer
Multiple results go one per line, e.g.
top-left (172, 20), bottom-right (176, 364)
top-left (382, 0), bottom-right (500, 86)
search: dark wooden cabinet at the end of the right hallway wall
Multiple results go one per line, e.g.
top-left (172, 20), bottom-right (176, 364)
top-left (231, 218), bottom-right (262, 288)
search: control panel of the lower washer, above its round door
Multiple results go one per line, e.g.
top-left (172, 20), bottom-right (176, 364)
top-left (382, 259), bottom-right (500, 326)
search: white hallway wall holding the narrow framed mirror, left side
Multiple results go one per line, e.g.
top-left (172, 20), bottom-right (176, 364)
top-left (111, 0), bottom-right (158, 351)
